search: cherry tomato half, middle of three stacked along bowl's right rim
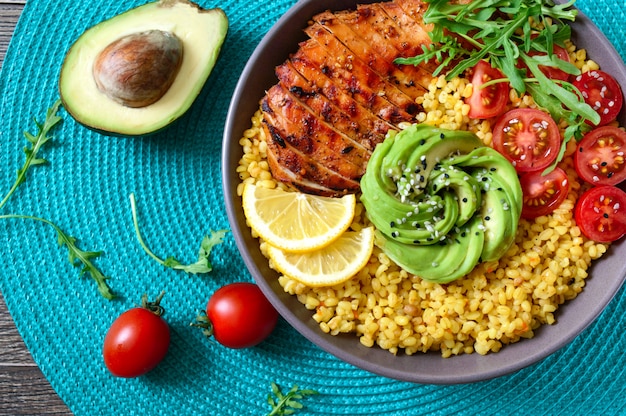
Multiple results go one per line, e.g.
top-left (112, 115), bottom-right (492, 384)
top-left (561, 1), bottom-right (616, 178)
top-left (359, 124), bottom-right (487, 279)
top-left (574, 126), bottom-right (626, 185)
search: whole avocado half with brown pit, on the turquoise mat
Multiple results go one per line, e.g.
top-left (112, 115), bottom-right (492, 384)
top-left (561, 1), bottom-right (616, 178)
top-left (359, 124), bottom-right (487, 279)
top-left (59, 0), bottom-right (228, 136)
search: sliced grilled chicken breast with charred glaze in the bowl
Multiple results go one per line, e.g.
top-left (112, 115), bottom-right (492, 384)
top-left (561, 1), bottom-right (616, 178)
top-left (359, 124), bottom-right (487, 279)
top-left (261, 0), bottom-right (435, 196)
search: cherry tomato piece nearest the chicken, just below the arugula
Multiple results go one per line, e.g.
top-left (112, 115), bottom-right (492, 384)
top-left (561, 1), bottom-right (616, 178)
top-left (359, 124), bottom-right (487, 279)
top-left (467, 61), bottom-right (509, 119)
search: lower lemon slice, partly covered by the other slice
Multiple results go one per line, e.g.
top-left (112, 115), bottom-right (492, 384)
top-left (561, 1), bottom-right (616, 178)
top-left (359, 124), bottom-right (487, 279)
top-left (267, 227), bottom-right (374, 287)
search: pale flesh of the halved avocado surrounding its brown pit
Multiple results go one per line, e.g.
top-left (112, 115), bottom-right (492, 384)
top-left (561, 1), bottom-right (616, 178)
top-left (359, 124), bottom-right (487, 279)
top-left (59, 0), bottom-right (228, 136)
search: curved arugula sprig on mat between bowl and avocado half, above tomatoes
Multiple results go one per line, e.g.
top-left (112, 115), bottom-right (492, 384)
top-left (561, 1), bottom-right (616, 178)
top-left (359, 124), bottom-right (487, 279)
top-left (130, 194), bottom-right (228, 274)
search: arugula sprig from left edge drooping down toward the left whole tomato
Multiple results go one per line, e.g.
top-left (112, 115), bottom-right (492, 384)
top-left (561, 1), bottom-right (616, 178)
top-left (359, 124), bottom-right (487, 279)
top-left (0, 214), bottom-right (115, 300)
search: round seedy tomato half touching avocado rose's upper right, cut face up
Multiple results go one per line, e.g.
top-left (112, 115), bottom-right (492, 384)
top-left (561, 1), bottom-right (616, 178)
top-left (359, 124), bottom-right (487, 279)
top-left (493, 108), bottom-right (561, 172)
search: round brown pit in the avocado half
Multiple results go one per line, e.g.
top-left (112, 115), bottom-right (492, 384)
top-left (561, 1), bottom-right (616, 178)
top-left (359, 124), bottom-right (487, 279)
top-left (93, 30), bottom-right (183, 108)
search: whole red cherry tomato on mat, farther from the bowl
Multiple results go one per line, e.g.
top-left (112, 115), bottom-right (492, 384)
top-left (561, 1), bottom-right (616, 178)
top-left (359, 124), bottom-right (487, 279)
top-left (102, 293), bottom-right (170, 378)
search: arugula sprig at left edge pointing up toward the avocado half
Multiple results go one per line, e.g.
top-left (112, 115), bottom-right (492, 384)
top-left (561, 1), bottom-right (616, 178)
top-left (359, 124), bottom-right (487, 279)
top-left (0, 99), bottom-right (62, 209)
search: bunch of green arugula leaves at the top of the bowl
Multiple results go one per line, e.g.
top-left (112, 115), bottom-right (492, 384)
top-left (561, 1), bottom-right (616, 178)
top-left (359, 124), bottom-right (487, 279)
top-left (396, 0), bottom-right (600, 170)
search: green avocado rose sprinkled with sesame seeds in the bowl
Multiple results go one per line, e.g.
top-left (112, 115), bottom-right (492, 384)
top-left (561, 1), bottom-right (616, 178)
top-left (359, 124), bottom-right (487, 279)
top-left (361, 124), bottom-right (522, 283)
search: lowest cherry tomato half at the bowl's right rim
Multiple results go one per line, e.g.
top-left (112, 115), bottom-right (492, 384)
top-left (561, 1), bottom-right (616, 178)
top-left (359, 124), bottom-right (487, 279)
top-left (574, 185), bottom-right (626, 243)
